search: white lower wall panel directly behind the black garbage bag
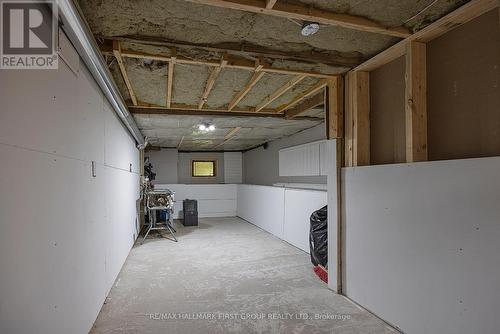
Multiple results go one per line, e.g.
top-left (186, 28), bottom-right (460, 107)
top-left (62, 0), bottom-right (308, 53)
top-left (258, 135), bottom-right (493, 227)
top-left (283, 189), bottom-right (327, 253)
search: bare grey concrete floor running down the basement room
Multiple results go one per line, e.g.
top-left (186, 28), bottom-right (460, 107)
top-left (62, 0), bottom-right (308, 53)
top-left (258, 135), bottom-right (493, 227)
top-left (91, 218), bottom-right (396, 334)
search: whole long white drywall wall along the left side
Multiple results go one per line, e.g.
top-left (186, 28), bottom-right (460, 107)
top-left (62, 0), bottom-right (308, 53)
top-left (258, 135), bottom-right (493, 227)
top-left (0, 46), bottom-right (139, 334)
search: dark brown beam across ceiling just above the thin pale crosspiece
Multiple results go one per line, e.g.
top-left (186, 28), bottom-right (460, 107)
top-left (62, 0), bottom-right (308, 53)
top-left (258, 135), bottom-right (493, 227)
top-left (105, 35), bottom-right (363, 67)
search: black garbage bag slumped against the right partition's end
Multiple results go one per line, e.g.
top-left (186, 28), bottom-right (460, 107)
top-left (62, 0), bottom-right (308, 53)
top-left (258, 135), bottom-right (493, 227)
top-left (309, 205), bottom-right (328, 268)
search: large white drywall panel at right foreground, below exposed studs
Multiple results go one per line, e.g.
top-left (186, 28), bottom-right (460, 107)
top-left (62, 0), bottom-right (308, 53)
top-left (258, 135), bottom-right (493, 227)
top-left (342, 157), bottom-right (500, 334)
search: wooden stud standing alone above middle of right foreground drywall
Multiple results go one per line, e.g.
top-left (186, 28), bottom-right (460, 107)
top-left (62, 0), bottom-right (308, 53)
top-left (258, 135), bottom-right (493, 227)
top-left (405, 42), bottom-right (427, 162)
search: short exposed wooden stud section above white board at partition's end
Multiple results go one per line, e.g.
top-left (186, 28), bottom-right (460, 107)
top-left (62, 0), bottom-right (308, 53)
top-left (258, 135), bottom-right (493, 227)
top-left (325, 77), bottom-right (344, 139)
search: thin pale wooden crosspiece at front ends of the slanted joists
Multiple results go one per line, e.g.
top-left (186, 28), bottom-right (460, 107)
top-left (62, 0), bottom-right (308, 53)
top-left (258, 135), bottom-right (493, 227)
top-left (101, 41), bottom-right (338, 78)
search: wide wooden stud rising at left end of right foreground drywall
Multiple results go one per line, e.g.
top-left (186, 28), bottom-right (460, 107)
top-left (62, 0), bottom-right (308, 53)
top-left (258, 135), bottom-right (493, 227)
top-left (345, 72), bottom-right (370, 167)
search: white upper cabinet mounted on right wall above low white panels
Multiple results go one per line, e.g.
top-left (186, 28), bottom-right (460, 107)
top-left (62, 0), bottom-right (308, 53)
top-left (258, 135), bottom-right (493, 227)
top-left (279, 140), bottom-right (326, 176)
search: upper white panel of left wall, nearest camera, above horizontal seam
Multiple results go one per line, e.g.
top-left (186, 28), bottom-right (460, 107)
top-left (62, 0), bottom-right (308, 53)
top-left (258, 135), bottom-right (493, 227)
top-left (0, 61), bottom-right (104, 163)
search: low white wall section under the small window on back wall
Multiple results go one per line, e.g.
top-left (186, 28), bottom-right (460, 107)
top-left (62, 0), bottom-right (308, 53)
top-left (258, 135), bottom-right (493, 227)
top-left (155, 184), bottom-right (236, 219)
